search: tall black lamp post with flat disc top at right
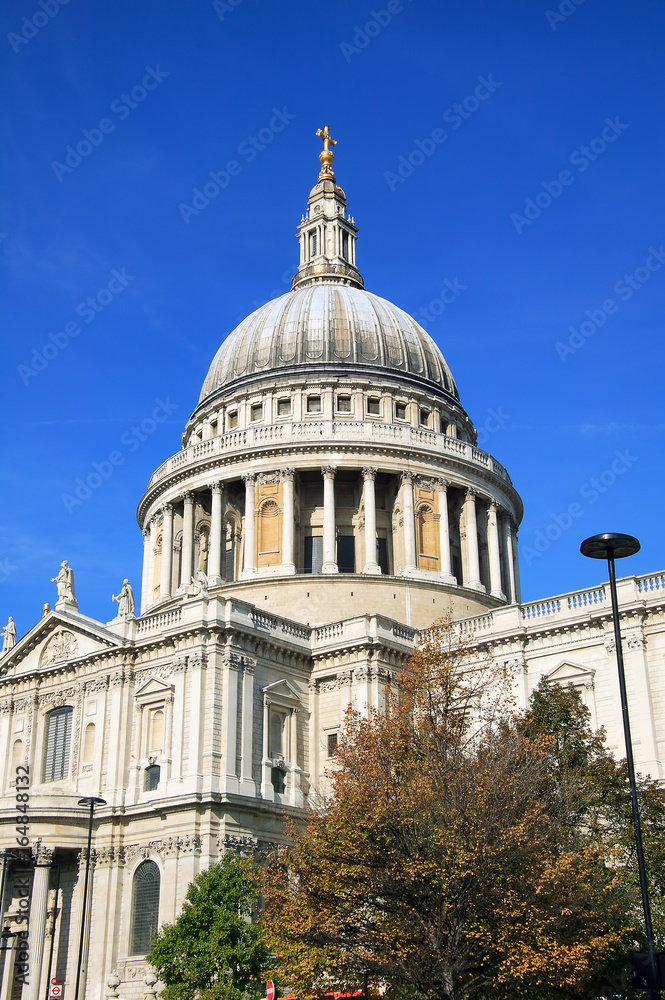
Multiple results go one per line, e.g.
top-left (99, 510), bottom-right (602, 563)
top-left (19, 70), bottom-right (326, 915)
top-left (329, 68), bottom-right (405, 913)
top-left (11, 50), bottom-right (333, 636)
top-left (580, 532), bottom-right (660, 1000)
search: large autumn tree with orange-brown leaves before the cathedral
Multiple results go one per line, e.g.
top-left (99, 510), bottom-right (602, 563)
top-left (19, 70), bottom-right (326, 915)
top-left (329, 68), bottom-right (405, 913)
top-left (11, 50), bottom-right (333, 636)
top-left (264, 623), bottom-right (652, 1000)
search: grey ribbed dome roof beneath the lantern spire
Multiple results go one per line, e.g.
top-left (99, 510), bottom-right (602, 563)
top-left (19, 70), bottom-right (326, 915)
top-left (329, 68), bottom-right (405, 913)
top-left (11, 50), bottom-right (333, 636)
top-left (199, 283), bottom-right (459, 403)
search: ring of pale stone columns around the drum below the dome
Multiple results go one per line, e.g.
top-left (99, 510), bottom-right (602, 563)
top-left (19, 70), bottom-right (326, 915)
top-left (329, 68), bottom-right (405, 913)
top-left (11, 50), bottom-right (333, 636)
top-left (141, 466), bottom-right (520, 612)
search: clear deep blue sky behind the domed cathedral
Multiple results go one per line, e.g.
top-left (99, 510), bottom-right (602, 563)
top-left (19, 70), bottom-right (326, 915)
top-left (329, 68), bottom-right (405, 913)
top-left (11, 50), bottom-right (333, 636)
top-left (0, 0), bottom-right (665, 633)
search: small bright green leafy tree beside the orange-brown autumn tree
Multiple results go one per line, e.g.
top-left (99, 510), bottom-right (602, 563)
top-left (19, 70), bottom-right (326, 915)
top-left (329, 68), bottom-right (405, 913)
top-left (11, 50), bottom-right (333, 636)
top-left (147, 851), bottom-right (269, 1000)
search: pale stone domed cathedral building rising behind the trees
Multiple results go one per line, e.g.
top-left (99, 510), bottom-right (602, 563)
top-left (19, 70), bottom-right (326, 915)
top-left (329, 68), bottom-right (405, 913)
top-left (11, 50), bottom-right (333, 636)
top-left (0, 143), bottom-right (665, 1000)
